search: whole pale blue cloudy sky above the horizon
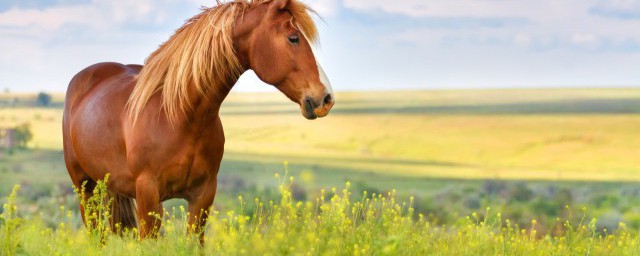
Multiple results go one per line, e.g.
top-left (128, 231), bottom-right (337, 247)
top-left (0, 0), bottom-right (640, 92)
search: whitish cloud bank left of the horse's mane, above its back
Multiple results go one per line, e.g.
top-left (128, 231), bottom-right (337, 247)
top-left (0, 0), bottom-right (200, 91)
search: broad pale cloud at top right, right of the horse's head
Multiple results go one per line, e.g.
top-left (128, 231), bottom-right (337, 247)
top-left (343, 0), bottom-right (640, 52)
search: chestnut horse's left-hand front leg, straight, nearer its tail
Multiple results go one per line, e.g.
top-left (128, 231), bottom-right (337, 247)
top-left (136, 176), bottom-right (162, 238)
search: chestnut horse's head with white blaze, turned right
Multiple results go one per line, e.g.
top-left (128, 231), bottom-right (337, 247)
top-left (234, 0), bottom-right (335, 119)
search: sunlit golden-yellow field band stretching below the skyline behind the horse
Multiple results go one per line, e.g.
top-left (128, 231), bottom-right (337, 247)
top-left (0, 89), bottom-right (640, 187)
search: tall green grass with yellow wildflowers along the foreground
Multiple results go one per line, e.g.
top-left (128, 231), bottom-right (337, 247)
top-left (0, 172), bottom-right (640, 255)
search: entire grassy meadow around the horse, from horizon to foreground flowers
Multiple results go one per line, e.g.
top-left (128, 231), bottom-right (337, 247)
top-left (0, 89), bottom-right (640, 255)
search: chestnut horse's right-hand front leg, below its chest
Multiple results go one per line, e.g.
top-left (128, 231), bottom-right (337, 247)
top-left (187, 179), bottom-right (217, 245)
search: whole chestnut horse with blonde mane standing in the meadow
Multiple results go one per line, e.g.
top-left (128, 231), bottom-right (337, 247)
top-left (62, 0), bottom-right (334, 239)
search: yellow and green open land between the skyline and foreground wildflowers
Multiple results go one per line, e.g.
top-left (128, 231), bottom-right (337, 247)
top-left (0, 89), bottom-right (640, 235)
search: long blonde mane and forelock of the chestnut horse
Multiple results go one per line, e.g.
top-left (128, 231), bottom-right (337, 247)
top-left (128, 0), bottom-right (318, 125)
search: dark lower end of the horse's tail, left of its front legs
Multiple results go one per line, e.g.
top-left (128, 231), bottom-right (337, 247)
top-left (109, 192), bottom-right (138, 233)
